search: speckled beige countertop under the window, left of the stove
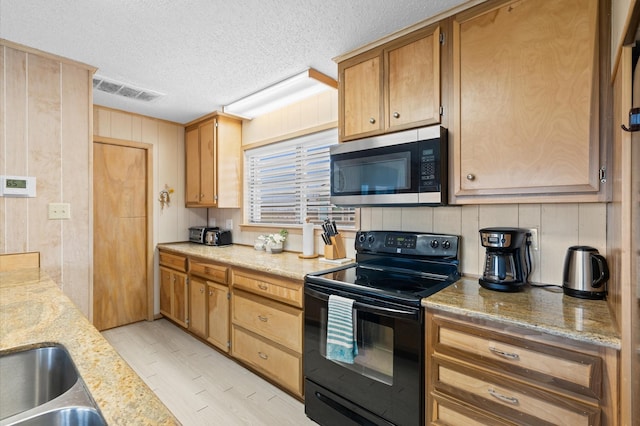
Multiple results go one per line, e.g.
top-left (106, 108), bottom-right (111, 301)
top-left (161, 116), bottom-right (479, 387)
top-left (158, 243), bottom-right (351, 284)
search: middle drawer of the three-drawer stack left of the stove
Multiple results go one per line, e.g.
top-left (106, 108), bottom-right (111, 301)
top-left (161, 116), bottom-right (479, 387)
top-left (231, 291), bottom-right (302, 353)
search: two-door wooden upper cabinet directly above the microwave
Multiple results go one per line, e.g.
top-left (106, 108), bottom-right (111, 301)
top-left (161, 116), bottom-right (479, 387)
top-left (338, 25), bottom-right (440, 141)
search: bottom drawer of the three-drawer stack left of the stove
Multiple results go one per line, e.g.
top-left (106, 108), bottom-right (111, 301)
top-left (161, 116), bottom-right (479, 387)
top-left (231, 325), bottom-right (302, 395)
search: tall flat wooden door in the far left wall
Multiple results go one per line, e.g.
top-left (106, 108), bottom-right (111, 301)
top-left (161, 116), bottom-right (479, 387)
top-left (93, 142), bottom-right (148, 330)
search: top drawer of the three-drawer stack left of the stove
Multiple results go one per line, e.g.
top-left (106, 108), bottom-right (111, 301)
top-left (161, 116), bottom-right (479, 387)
top-left (233, 269), bottom-right (303, 308)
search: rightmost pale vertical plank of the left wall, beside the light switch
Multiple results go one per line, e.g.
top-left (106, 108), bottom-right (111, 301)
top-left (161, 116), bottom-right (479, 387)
top-left (60, 63), bottom-right (93, 312)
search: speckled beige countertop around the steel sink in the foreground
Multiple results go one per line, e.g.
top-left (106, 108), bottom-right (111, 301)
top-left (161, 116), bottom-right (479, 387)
top-left (0, 269), bottom-right (180, 425)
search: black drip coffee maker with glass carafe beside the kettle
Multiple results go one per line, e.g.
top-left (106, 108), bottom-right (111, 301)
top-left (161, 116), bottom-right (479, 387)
top-left (478, 228), bottom-right (531, 292)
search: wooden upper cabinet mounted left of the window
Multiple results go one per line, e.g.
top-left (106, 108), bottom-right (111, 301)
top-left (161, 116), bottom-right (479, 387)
top-left (185, 113), bottom-right (242, 208)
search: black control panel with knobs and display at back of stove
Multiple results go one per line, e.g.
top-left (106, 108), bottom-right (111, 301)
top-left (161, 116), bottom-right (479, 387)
top-left (355, 231), bottom-right (460, 258)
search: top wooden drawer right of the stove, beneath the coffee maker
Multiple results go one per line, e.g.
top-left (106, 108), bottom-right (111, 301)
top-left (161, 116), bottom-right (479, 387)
top-left (434, 317), bottom-right (602, 398)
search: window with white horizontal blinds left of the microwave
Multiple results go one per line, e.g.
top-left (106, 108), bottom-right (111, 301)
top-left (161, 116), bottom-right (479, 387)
top-left (244, 129), bottom-right (355, 228)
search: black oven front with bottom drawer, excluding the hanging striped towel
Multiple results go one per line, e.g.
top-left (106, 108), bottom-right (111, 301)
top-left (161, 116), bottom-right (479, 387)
top-left (304, 282), bottom-right (424, 425)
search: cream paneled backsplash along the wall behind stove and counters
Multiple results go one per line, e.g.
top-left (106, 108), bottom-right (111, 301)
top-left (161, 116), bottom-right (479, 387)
top-left (209, 203), bottom-right (607, 285)
